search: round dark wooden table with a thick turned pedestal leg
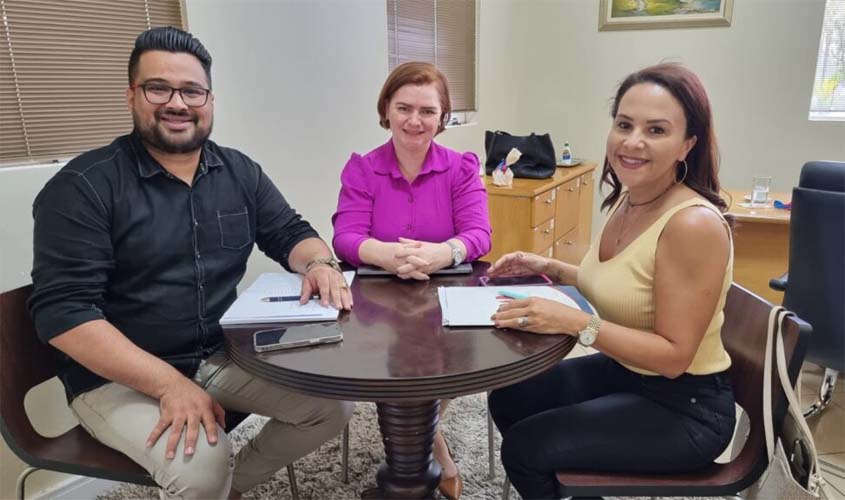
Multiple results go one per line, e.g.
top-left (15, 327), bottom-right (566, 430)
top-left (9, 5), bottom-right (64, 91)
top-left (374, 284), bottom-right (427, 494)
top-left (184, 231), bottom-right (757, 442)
top-left (225, 263), bottom-right (575, 499)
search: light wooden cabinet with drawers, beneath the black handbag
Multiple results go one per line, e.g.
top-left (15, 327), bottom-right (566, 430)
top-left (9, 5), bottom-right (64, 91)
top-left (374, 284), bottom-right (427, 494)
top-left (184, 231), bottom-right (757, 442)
top-left (484, 162), bottom-right (596, 264)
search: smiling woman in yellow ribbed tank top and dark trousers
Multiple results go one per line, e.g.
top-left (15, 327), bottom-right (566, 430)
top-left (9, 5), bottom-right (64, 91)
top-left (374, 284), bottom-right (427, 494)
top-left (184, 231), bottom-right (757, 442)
top-left (489, 64), bottom-right (734, 499)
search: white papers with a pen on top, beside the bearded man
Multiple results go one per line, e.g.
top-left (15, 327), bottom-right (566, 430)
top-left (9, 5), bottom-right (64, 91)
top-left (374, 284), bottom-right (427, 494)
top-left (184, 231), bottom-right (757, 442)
top-left (220, 271), bottom-right (355, 325)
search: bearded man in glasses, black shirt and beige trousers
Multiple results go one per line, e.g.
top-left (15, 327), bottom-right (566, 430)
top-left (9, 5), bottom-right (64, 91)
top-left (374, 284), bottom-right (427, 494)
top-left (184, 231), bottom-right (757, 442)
top-left (29, 27), bottom-right (352, 498)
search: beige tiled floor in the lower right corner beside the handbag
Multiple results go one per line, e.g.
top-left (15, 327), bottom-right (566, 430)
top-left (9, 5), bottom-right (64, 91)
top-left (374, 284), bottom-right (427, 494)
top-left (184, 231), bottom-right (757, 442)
top-left (801, 363), bottom-right (845, 499)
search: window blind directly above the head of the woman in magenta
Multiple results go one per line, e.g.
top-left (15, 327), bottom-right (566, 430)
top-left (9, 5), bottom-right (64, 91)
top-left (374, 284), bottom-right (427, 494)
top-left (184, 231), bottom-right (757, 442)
top-left (387, 0), bottom-right (476, 111)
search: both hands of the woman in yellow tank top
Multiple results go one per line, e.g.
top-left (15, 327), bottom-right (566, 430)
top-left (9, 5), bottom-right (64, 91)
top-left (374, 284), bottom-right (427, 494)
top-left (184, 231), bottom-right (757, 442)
top-left (487, 252), bottom-right (589, 335)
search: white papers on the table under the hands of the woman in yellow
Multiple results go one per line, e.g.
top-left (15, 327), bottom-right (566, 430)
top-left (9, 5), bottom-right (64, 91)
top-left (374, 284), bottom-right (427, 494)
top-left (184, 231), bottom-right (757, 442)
top-left (437, 286), bottom-right (594, 326)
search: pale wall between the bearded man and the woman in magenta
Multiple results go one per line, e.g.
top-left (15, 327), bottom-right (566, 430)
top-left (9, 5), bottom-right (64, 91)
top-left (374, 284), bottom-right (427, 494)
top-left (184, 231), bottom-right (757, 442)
top-left (186, 0), bottom-right (387, 288)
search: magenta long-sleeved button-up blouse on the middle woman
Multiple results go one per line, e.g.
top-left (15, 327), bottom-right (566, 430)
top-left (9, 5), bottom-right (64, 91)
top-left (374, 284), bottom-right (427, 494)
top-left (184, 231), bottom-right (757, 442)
top-left (332, 140), bottom-right (491, 266)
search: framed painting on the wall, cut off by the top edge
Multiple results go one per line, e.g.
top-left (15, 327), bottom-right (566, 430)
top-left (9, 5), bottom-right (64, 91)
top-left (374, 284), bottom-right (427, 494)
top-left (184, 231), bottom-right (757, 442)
top-left (599, 0), bottom-right (733, 31)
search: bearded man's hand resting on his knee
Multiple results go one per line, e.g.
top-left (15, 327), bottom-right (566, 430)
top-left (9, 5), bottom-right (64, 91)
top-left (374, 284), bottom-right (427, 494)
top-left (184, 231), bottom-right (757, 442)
top-left (147, 374), bottom-right (226, 460)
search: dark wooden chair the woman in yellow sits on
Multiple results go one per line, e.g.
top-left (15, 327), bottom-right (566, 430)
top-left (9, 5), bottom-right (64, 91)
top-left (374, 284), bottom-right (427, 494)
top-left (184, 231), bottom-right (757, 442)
top-left (503, 284), bottom-right (811, 498)
